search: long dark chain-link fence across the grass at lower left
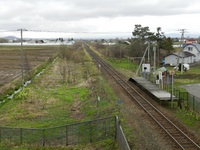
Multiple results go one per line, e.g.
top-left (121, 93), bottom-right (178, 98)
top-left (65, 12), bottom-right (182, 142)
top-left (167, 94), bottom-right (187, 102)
top-left (0, 117), bottom-right (116, 146)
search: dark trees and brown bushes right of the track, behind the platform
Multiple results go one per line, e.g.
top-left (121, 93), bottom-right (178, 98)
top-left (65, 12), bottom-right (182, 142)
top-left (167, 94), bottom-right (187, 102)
top-left (95, 24), bottom-right (174, 63)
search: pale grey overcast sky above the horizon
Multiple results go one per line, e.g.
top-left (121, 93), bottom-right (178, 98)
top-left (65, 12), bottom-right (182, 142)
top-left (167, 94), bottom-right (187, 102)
top-left (0, 0), bottom-right (200, 38)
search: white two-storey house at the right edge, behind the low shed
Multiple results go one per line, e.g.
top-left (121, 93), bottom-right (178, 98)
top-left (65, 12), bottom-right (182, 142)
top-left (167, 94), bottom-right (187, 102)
top-left (183, 43), bottom-right (200, 63)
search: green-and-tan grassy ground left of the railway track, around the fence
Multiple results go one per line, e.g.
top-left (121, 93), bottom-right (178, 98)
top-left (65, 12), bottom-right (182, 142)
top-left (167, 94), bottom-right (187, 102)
top-left (0, 44), bottom-right (118, 149)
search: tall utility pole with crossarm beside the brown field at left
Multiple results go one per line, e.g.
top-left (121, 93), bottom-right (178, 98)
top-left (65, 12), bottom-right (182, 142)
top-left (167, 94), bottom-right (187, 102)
top-left (17, 28), bottom-right (27, 88)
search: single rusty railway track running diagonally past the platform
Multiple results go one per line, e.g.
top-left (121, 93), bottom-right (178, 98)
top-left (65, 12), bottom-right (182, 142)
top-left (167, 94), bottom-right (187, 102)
top-left (87, 45), bottom-right (200, 150)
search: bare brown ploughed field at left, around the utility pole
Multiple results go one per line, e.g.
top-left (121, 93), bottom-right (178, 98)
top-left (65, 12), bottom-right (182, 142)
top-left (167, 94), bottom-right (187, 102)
top-left (0, 46), bottom-right (59, 98)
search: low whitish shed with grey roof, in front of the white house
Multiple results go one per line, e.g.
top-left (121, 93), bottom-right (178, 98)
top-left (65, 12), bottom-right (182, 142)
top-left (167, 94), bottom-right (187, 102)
top-left (165, 52), bottom-right (195, 66)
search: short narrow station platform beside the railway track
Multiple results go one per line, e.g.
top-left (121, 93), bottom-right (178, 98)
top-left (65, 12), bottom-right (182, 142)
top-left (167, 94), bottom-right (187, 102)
top-left (129, 77), bottom-right (176, 101)
